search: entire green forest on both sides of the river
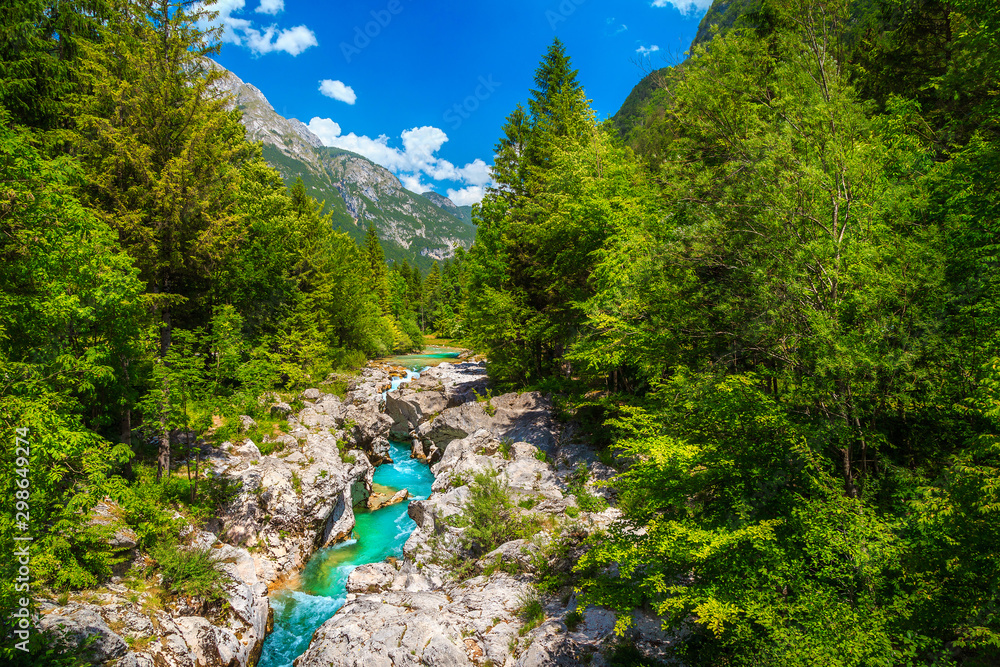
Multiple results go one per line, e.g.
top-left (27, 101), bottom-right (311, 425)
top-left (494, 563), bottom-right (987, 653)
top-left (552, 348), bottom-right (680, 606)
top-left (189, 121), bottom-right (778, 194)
top-left (0, 0), bottom-right (1000, 666)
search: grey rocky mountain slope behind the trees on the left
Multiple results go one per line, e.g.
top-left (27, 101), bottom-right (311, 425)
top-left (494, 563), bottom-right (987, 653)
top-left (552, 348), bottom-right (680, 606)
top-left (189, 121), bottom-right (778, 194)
top-left (212, 62), bottom-right (476, 270)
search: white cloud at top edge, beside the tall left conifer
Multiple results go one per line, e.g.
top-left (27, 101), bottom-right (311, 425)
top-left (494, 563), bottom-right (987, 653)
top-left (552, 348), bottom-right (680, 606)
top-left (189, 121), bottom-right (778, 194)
top-left (197, 0), bottom-right (319, 56)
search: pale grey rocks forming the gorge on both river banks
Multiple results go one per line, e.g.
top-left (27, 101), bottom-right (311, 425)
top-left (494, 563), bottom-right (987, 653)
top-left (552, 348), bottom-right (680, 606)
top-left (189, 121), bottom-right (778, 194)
top-left (41, 361), bottom-right (671, 667)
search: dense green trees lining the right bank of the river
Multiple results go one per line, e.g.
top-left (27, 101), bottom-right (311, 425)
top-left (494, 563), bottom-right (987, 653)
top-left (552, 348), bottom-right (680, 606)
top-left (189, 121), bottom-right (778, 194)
top-left (459, 0), bottom-right (1000, 665)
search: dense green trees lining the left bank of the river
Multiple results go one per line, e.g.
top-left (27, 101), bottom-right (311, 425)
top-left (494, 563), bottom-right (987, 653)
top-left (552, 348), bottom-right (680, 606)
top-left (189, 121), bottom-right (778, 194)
top-left (0, 0), bottom-right (422, 660)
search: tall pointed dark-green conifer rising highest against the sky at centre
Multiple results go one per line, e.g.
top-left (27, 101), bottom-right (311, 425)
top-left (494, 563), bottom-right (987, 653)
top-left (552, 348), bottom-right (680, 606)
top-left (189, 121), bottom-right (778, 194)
top-left (464, 39), bottom-right (606, 383)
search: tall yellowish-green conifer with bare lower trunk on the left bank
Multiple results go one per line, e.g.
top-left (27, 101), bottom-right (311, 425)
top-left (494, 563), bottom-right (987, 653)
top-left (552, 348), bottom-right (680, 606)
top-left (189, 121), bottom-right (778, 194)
top-left (75, 0), bottom-right (252, 475)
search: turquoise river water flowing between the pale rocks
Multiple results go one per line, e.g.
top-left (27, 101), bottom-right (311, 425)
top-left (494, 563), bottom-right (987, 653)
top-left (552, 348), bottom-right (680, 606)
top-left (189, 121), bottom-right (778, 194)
top-left (258, 348), bottom-right (457, 667)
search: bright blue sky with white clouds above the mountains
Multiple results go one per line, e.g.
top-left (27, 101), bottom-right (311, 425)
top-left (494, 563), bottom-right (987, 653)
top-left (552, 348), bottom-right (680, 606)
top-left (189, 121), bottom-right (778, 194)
top-left (201, 0), bottom-right (711, 204)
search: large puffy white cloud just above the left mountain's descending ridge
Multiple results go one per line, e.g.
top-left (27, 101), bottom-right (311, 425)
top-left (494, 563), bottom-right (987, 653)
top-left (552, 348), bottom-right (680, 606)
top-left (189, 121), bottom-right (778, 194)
top-left (309, 117), bottom-right (492, 203)
